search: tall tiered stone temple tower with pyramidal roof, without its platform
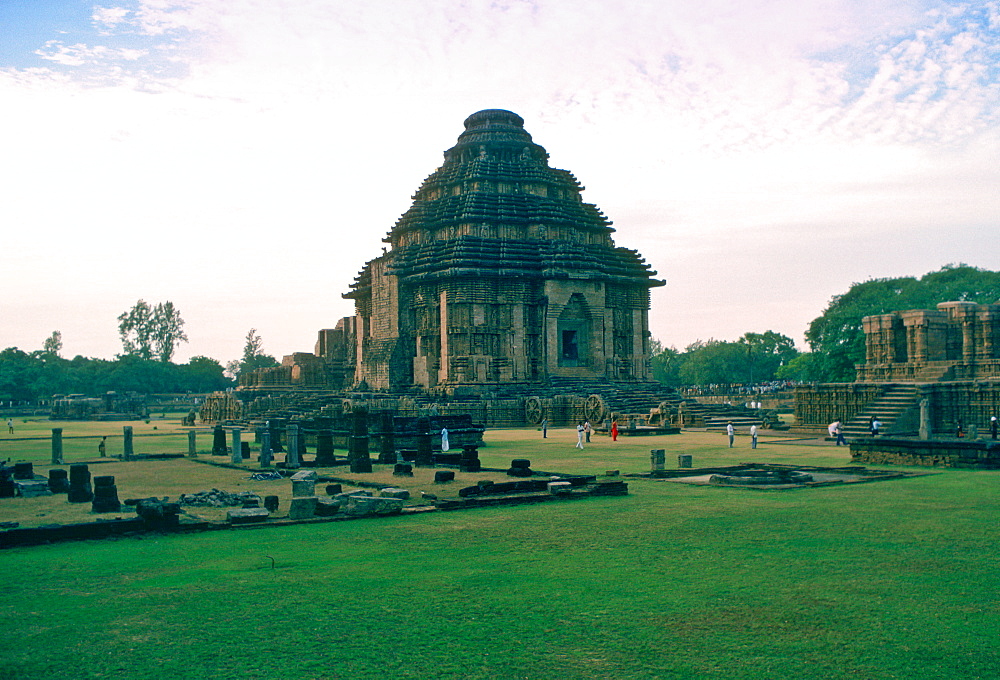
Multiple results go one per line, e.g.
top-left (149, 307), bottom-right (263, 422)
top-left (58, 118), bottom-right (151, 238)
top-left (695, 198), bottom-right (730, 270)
top-left (344, 109), bottom-right (664, 389)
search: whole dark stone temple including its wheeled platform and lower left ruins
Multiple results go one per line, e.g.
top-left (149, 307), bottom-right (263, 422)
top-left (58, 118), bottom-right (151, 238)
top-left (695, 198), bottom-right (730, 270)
top-left (195, 109), bottom-right (740, 427)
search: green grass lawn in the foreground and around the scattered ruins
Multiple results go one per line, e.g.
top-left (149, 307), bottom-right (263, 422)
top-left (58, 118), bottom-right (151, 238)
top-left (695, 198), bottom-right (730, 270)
top-left (0, 421), bottom-right (1000, 680)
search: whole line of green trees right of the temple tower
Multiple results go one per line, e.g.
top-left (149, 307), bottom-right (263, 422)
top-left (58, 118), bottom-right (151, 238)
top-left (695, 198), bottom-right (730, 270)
top-left (651, 264), bottom-right (1000, 386)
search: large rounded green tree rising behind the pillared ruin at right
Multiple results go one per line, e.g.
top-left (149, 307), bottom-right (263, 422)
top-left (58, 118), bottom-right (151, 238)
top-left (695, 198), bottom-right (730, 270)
top-left (806, 264), bottom-right (1000, 382)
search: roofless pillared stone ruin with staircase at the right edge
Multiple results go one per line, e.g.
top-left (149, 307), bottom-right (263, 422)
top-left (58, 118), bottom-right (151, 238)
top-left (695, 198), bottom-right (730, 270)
top-left (793, 302), bottom-right (1000, 448)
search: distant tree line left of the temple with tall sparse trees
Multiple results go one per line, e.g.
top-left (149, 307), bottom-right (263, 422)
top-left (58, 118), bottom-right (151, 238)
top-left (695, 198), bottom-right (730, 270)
top-left (0, 300), bottom-right (278, 402)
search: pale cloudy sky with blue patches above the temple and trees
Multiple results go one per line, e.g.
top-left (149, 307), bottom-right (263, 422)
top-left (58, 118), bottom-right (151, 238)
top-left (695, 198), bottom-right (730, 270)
top-left (0, 0), bottom-right (1000, 363)
